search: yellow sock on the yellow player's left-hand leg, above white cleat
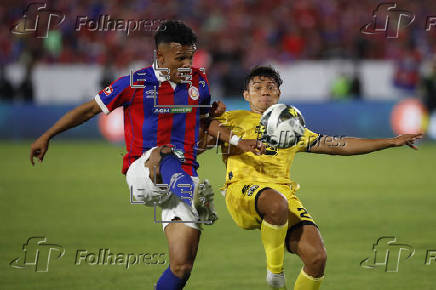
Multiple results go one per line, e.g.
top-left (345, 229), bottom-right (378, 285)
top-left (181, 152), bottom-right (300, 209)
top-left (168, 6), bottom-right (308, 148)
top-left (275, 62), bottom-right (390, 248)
top-left (260, 220), bottom-right (288, 274)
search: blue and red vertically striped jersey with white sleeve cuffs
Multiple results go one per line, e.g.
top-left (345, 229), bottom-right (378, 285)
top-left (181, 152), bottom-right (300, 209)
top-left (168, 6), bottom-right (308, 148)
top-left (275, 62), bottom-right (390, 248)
top-left (95, 66), bottom-right (210, 176)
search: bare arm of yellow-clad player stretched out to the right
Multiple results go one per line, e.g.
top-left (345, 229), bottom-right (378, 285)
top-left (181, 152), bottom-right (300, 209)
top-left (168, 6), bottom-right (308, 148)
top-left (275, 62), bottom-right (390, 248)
top-left (310, 134), bottom-right (423, 156)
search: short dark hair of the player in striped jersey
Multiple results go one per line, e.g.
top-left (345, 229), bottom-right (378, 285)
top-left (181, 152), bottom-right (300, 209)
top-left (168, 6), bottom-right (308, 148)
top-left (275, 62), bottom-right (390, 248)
top-left (154, 20), bottom-right (197, 47)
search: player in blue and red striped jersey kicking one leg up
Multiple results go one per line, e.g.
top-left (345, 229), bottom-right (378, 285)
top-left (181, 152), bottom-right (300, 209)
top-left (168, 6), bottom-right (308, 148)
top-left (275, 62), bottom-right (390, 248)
top-left (30, 21), bottom-right (257, 290)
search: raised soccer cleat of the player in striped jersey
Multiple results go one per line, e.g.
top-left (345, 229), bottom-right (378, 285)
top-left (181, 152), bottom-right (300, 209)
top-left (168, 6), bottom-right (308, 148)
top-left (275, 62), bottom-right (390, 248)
top-left (193, 179), bottom-right (218, 225)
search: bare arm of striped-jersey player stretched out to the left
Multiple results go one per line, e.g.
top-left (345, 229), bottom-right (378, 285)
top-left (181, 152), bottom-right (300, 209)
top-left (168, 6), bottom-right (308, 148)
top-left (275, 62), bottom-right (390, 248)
top-left (30, 100), bottom-right (101, 165)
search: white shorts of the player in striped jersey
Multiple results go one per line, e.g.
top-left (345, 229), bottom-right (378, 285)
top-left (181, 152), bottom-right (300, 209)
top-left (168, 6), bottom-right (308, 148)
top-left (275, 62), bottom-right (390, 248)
top-left (126, 147), bottom-right (202, 230)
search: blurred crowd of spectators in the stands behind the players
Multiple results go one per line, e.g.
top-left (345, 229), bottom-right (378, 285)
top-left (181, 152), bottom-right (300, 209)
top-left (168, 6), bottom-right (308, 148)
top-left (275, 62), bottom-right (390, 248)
top-left (0, 0), bottom-right (436, 103)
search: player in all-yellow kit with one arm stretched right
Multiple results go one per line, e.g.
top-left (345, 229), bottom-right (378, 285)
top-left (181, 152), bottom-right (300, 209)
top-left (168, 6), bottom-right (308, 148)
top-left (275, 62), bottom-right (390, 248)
top-left (209, 67), bottom-right (422, 290)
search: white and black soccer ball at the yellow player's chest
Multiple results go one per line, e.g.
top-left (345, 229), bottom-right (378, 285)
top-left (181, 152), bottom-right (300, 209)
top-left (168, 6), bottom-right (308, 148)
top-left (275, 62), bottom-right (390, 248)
top-left (260, 104), bottom-right (305, 148)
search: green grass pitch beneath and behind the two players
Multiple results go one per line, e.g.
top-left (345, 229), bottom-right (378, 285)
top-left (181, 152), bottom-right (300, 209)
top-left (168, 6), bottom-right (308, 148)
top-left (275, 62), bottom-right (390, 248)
top-left (0, 140), bottom-right (436, 290)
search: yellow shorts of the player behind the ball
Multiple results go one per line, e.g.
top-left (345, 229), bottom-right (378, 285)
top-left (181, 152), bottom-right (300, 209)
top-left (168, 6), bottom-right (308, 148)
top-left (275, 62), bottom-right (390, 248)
top-left (226, 182), bottom-right (316, 230)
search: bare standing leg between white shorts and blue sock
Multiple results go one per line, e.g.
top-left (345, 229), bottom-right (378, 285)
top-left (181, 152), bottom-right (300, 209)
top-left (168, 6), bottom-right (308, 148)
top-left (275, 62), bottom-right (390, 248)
top-left (165, 223), bottom-right (200, 265)
